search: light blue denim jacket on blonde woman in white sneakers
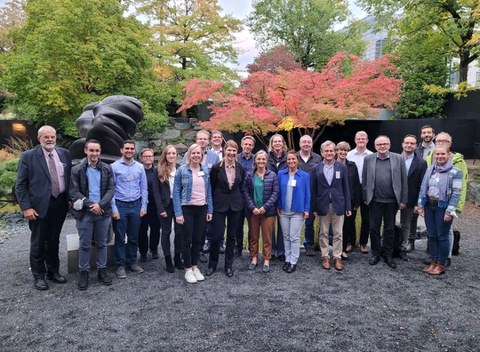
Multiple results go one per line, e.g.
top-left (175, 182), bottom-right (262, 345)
top-left (172, 164), bottom-right (213, 217)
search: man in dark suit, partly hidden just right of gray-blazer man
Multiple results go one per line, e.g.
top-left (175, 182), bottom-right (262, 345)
top-left (400, 134), bottom-right (427, 261)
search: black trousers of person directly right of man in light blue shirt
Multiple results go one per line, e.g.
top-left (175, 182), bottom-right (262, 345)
top-left (138, 206), bottom-right (160, 256)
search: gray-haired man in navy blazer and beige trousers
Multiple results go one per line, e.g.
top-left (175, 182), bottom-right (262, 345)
top-left (310, 141), bottom-right (352, 270)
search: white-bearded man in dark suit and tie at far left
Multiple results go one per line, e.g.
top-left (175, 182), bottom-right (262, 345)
top-left (15, 125), bottom-right (72, 290)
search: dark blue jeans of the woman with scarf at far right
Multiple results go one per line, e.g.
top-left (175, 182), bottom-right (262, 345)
top-left (425, 202), bottom-right (452, 265)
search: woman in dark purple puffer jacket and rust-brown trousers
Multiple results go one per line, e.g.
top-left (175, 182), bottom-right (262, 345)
top-left (243, 150), bottom-right (278, 273)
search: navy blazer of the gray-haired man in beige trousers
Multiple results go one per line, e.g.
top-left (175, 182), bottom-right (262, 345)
top-left (310, 160), bottom-right (352, 216)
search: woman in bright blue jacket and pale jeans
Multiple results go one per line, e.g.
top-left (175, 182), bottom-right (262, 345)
top-left (277, 150), bottom-right (310, 273)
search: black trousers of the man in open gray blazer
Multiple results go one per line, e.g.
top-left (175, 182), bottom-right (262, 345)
top-left (368, 200), bottom-right (398, 257)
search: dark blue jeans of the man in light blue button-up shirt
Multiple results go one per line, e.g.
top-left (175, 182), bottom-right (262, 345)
top-left (113, 198), bottom-right (142, 267)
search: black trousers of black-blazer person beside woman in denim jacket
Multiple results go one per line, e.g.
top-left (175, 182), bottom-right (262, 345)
top-left (208, 210), bottom-right (242, 269)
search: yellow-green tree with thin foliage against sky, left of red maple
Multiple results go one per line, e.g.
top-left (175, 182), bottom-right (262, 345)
top-left (134, 0), bottom-right (241, 115)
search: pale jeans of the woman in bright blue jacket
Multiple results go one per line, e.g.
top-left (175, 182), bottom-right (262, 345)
top-left (280, 210), bottom-right (305, 264)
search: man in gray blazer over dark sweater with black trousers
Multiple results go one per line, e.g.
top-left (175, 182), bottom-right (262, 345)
top-left (362, 136), bottom-right (408, 268)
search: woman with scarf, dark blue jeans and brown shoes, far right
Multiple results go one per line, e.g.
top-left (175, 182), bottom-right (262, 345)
top-left (417, 146), bottom-right (462, 275)
